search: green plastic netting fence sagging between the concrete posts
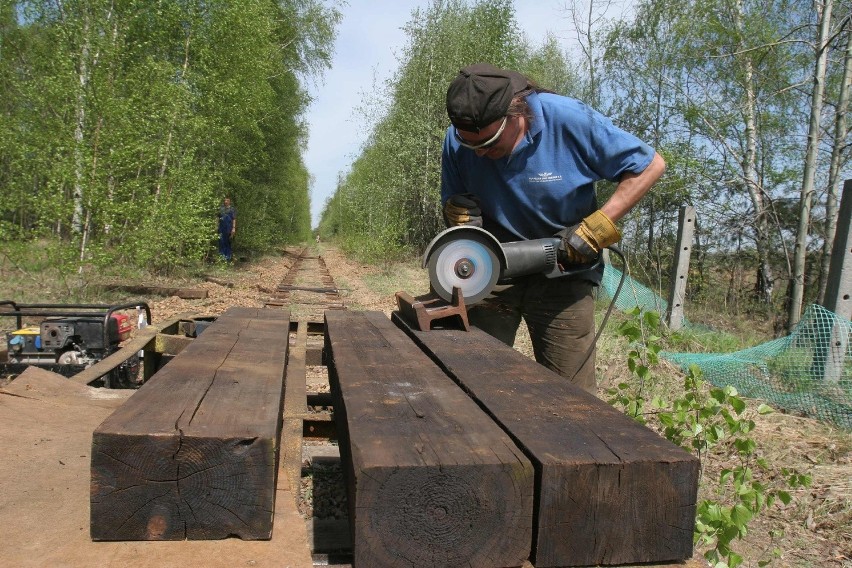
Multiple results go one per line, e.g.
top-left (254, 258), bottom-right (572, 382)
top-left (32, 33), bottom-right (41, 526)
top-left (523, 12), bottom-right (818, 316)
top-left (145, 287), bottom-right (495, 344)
top-left (600, 265), bottom-right (852, 429)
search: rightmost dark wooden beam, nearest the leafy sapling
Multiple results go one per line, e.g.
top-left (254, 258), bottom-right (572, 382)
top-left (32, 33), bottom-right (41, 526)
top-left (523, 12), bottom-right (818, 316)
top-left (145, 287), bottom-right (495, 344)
top-left (393, 314), bottom-right (699, 568)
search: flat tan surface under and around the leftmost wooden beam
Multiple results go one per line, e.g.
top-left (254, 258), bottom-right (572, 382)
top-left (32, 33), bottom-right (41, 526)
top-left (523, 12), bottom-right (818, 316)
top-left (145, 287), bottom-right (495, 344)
top-left (0, 367), bottom-right (313, 568)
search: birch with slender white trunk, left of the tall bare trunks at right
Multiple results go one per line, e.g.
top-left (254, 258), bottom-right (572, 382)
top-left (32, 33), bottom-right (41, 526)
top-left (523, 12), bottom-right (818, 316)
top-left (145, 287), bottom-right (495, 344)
top-left (672, 0), bottom-right (803, 304)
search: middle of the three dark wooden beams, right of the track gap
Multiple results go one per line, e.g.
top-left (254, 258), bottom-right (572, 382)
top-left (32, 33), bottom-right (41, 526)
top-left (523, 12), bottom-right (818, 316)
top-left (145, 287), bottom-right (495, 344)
top-left (325, 311), bottom-right (533, 568)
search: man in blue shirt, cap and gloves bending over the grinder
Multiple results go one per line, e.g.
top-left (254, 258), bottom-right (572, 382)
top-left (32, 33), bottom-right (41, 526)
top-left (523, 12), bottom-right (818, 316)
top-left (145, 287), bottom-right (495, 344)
top-left (441, 63), bottom-right (665, 393)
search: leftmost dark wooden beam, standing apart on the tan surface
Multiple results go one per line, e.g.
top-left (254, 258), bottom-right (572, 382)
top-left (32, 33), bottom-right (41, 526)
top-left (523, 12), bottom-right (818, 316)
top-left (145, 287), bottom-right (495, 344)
top-left (90, 308), bottom-right (289, 540)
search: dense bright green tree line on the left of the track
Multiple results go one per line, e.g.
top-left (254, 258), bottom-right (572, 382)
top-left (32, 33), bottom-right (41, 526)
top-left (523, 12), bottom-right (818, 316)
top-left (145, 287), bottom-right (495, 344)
top-left (0, 0), bottom-right (340, 270)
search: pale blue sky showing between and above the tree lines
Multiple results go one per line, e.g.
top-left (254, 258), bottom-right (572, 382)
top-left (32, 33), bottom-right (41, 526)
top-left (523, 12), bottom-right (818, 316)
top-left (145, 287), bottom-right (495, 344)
top-left (304, 0), bottom-right (571, 226)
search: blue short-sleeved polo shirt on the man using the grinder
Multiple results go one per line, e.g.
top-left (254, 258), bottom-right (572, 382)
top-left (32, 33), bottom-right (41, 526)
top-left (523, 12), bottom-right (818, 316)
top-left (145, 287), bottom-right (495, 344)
top-left (441, 93), bottom-right (655, 242)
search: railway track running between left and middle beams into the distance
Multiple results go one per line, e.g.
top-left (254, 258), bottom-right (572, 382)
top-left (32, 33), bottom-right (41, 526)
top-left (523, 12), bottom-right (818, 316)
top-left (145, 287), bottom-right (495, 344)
top-left (272, 247), bottom-right (352, 567)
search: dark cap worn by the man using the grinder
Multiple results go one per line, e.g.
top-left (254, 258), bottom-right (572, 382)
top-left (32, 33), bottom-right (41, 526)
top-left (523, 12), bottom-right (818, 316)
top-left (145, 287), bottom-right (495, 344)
top-left (447, 63), bottom-right (529, 132)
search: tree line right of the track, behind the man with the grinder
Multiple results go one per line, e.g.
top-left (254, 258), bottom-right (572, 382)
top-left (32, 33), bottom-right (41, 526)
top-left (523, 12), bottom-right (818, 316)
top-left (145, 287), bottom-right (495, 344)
top-left (320, 0), bottom-right (852, 332)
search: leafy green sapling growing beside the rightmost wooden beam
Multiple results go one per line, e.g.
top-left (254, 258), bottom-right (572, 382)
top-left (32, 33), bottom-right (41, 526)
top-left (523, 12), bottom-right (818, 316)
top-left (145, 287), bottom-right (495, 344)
top-left (608, 308), bottom-right (811, 568)
